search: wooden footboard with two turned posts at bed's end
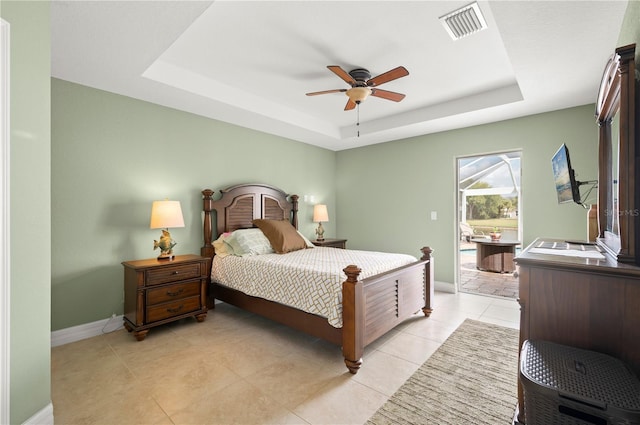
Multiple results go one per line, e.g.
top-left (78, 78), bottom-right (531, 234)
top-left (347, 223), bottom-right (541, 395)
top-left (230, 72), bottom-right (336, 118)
top-left (342, 247), bottom-right (433, 374)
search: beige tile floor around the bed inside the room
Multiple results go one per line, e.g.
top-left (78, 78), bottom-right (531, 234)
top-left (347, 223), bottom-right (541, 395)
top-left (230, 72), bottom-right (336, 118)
top-left (51, 293), bottom-right (519, 424)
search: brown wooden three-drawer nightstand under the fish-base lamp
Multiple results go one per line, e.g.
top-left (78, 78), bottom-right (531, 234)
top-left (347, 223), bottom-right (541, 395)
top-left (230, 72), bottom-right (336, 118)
top-left (122, 255), bottom-right (209, 341)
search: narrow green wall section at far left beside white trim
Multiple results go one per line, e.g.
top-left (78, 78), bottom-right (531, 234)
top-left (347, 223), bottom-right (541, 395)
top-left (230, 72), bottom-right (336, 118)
top-left (0, 1), bottom-right (51, 423)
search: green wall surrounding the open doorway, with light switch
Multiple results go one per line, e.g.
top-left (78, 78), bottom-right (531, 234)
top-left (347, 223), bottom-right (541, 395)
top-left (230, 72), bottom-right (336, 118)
top-left (337, 104), bottom-right (604, 284)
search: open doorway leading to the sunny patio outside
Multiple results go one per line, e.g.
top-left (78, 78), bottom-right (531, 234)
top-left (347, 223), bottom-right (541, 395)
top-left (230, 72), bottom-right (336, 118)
top-left (456, 151), bottom-right (522, 298)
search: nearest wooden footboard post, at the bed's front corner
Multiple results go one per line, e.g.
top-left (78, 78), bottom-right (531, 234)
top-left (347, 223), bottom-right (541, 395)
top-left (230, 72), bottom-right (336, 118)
top-left (342, 265), bottom-right (364, 374)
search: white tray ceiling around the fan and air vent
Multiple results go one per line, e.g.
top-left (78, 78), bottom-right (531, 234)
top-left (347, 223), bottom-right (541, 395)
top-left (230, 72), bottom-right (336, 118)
top-left (51, 0), bottom-right (627, 151)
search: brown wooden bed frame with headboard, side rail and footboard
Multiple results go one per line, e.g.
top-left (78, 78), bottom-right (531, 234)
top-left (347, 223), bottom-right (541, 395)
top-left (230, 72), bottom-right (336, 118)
top-left (201, 184), bottom-right (433, 374)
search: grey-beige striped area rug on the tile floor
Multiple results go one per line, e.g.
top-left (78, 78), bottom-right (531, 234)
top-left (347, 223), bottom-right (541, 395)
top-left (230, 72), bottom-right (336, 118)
top-left (367, 319), bottom-right (518, 425)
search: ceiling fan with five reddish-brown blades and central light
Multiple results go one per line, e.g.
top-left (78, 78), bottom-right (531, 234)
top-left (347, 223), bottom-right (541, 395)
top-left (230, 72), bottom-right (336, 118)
top-left (307, 65), bottom-right (409, 111)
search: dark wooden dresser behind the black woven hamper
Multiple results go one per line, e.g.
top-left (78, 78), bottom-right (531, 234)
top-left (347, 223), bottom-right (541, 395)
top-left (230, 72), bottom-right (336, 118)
top-left (515, 239), bottom-right (640, 421)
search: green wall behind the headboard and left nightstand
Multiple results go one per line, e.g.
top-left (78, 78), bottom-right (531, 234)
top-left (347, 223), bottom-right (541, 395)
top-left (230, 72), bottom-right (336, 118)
top-left (51, 79), bottom-right (336, 330)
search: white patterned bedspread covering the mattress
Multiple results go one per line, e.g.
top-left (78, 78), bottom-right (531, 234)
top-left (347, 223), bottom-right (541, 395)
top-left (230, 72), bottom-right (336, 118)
top-left (211, 247), bottom-right (417, 328)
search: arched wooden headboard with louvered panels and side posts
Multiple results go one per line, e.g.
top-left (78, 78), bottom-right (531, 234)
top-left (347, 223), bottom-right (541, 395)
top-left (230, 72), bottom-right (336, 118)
top-left (200, 184), bottom-right (298, 257)
